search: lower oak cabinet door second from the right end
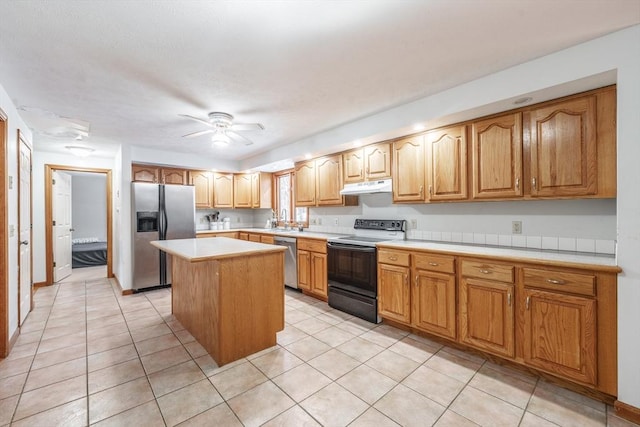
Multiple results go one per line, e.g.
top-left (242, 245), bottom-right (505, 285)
top-left (459, 277), bottom-right (514, 357)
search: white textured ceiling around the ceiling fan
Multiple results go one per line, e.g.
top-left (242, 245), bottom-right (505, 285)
top-left (0, 0), bottom-right (640, 166)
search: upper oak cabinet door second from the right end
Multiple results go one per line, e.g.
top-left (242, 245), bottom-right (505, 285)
top-left (471, 113), bottom-right (522, 199)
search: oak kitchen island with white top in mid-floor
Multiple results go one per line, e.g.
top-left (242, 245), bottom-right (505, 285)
top-left (151, 237), bottom-right (286, 366)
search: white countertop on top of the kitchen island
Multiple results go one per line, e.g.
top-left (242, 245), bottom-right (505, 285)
top-left (151, 237), bottom-right (286, 262)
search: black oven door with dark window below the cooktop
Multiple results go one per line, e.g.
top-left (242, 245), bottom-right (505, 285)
top-left (327, 242), bottom-right (378, 298)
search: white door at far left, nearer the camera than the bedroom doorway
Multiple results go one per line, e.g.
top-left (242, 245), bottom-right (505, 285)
top-left (18, 140), bottom-right (32, 325)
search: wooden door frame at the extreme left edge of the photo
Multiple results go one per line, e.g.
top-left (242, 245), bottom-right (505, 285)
top-left (0, 109), bottom-right (11, 358)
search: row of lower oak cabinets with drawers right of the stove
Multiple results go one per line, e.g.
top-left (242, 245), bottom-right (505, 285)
top-left (378, 246), bottom-right (619, 399)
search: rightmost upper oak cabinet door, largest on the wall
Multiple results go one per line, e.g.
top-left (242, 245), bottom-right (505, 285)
top-left (529, 95), bottom-right (598, 197)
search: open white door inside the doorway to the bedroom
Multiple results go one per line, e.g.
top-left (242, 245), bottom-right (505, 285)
top-left (52, 171), bottom-right (71, 282)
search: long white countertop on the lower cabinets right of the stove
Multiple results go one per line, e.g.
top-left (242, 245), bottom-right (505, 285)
top-left (378, 240), bottom-right (618, 268)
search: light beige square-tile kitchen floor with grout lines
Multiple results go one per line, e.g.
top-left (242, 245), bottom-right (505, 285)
top-left (0, 273), bottom-right (634, 427)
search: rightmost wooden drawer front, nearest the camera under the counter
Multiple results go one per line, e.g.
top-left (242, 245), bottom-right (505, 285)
top-left (524, 268), bottom-right (596, 296)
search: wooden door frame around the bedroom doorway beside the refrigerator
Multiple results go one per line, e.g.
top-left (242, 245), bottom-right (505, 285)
top-left (44, 164), bottom-right (113, 285)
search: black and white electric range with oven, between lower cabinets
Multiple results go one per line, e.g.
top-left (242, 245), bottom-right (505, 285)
top-left (327, 219), bottom-right (406, 323)
